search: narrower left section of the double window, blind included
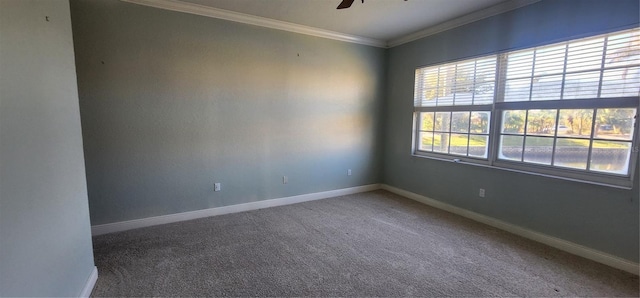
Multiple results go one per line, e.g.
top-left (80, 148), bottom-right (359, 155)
top-left (415, 56), bottom-right (496, 158)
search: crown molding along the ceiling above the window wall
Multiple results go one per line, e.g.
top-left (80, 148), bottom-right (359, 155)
top-left (387, 0), bottom-right (540, 48)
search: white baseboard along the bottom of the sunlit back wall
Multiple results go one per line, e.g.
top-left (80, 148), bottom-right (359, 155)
top-left (91, 184), bottom-right (380, 236)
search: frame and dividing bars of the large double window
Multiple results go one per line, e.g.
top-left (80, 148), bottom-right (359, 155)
top-left (411, 28), bottom-right (640, 189)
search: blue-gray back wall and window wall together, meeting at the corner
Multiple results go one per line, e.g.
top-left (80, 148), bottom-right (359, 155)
top-left (71, 0), bottom-right (639, 261)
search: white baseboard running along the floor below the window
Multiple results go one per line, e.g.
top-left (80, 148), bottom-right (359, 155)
top-left (381, 184), bottom-right (640, 275)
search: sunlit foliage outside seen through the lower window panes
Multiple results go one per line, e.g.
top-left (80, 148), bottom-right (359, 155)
top-left (420, 109), bottom-right (636, 148)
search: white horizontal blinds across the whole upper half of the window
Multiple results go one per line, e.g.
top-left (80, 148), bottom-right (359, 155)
top-left (414, 28), bottom-right (640, 107)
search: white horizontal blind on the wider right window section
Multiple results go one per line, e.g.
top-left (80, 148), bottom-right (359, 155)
top-left (501, 29), bottom-right (640, 102)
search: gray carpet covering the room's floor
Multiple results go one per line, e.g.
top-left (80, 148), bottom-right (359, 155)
top-left (92, 190), bottom-right (639, 297)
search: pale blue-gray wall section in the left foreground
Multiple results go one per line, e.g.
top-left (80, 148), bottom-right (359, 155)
top-left (0, 0), bottom-right (95, 297)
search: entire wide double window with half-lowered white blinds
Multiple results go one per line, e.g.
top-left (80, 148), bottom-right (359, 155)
top-left (413, 29), bottom-right (640, 187)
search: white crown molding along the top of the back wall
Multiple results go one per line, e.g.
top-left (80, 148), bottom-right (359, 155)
top-left (120, 0), bottom-right (387, 48)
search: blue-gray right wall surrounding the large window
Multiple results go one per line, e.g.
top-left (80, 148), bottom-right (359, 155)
top-left (383, 0), bottom-right (640, 262)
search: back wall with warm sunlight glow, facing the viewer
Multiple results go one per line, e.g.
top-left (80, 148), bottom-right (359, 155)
top-left (71, 0), bottom-right (385, 225)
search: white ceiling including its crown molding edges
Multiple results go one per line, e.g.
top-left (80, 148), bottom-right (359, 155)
top-left (122, 0), bottom-right (539, 47)
